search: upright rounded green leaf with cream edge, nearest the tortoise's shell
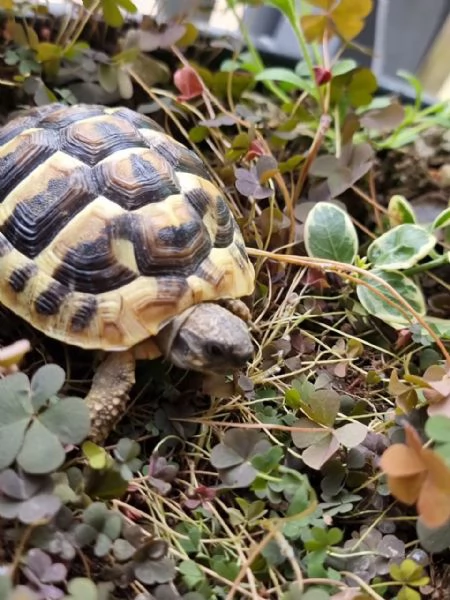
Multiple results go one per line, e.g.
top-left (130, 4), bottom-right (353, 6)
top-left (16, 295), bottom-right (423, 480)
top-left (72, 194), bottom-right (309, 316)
top-left (305, 202), bottom-right (358, 264)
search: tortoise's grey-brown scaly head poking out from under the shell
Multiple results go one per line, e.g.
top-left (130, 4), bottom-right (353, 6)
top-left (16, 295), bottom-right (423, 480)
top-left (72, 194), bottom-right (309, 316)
top-left (156, 302), bottom-right (254, 373)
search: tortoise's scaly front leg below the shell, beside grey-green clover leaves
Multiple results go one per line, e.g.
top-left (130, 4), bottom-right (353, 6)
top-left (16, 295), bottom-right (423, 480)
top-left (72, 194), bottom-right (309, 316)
top-left (85, 350), bottom-right (136, 444)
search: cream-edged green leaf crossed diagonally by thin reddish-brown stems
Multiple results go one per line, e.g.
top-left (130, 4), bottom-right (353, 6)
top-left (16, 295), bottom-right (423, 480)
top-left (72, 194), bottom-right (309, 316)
top-left (356, 269), bottom-right (426, 328)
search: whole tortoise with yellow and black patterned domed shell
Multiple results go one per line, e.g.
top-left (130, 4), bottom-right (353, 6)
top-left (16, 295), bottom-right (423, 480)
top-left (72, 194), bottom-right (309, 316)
top-left (0, 103), bottom-right (255, 441)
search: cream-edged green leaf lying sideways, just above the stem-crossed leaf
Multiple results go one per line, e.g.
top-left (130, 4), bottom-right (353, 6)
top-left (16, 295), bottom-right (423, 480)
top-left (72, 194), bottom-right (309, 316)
top-left (367, 223), bottom-right (437, 271)
